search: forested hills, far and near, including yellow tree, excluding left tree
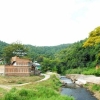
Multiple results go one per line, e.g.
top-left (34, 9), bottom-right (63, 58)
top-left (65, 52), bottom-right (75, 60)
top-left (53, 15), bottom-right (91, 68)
top-left (0, 27), bottom-right (100, 73)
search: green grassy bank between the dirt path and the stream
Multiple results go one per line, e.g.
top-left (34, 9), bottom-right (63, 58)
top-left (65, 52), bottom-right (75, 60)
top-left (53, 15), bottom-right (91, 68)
top-left (1, 75), bottom-right (73, 100)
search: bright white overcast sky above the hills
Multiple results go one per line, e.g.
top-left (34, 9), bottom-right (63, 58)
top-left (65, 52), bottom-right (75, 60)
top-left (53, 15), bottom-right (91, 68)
top-left (0, 0), bottom-right (100, 46)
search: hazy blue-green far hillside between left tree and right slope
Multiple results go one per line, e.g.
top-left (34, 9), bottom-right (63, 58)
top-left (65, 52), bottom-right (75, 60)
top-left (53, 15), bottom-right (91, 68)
top-left (25, 44), bottom-right (70, 61)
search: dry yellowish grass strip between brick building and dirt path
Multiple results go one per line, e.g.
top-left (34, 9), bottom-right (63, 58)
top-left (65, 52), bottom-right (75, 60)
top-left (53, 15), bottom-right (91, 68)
top-left (0, 76), bottom-right (43, 85)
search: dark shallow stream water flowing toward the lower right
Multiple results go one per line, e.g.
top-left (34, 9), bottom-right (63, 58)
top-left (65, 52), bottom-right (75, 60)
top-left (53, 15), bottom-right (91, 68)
top-left (60, 77), bottom-right (97, 100)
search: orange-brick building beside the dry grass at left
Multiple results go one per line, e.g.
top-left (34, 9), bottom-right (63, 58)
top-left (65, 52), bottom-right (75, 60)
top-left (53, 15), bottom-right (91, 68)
top-left (1, 56), bottom-right (40, 76)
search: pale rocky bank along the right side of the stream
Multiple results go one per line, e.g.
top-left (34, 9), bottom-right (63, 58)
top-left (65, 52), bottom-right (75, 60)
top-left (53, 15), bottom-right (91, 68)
top-left (66, 74), bottom-right (100, 100)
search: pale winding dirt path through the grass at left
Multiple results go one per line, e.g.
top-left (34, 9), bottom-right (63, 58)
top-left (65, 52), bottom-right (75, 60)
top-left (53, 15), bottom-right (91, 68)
top-left (0, 74), bottom-right (50, 90)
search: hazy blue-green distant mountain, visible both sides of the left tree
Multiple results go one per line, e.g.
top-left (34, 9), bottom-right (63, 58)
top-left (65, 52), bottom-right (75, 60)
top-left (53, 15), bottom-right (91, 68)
top-left (0, 41), bottom-right (70, 59)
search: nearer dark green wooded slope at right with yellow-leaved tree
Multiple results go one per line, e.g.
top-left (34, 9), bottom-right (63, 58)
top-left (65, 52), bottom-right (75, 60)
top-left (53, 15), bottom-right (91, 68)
top-left (43, 27), bottom-right (100, 73)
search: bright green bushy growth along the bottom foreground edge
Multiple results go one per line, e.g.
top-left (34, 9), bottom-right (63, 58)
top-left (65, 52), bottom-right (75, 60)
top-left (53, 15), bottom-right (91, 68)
top-left (4, 87), bottom-right (73, 100)
